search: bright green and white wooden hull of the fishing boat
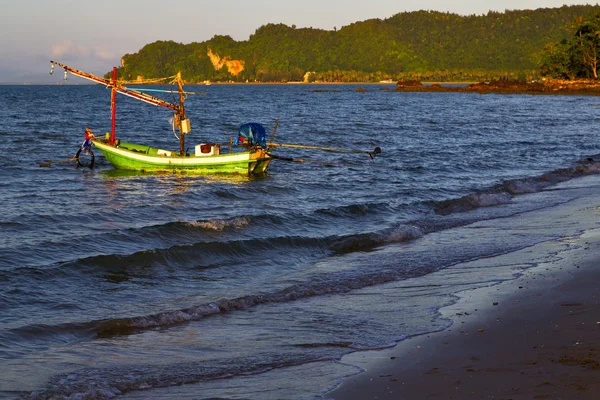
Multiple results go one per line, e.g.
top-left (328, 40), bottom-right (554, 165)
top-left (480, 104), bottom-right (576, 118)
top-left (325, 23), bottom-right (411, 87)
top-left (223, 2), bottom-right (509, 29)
top-left (93, 140), bottom-right (271, 175)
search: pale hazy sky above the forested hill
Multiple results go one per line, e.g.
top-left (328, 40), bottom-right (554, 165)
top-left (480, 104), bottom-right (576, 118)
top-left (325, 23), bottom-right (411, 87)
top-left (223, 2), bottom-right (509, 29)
top-left (0, 0), bottom-right (595, 83)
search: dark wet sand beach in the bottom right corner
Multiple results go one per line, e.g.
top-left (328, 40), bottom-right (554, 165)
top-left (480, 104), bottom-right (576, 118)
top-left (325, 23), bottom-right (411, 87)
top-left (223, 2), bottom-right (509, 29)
top-left (326, 231), bottom-right (600, 400)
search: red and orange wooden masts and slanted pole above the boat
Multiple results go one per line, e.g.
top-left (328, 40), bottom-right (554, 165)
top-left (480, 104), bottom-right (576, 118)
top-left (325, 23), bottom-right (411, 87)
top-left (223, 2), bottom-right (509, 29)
top-left (50, 61), bottom-right (190, 157)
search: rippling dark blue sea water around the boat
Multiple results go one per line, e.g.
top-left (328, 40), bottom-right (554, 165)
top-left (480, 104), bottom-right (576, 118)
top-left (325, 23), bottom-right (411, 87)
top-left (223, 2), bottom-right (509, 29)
top-left (0, 85), bottom-right (600, 399)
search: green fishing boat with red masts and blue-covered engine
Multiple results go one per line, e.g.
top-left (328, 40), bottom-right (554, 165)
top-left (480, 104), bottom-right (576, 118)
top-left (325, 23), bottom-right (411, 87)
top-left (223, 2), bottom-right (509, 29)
top-left (50, 61), bottom-right (275, 175)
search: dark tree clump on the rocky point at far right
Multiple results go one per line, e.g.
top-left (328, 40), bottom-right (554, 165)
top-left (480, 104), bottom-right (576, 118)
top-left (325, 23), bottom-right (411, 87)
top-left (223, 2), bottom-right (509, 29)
top-left (540, 12), bottom-right (600, 79)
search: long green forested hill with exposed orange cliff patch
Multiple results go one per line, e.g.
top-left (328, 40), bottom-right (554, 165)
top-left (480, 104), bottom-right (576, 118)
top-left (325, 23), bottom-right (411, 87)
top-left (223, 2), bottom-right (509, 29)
top-left (113, 5), bottom-right (600, 82)
